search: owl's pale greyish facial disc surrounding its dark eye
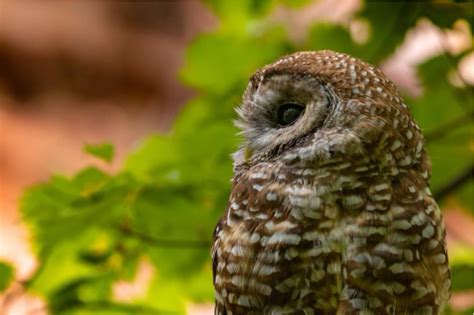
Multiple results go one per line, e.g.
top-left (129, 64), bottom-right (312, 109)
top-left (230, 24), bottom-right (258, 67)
top-left (237, 74), bottom-right (330, 157)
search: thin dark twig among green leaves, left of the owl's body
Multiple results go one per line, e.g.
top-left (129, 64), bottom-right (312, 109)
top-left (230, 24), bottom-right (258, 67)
top-left (118, 225), bottom-right (211, 249)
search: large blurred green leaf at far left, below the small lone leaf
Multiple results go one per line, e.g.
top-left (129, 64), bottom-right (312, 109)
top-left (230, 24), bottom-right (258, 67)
top-left (21, 168), bottom-right (133, 252)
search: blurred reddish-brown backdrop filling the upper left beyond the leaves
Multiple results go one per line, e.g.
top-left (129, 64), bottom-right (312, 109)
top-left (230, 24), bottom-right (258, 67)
top-left (0, 0), bottom-right (216, 277)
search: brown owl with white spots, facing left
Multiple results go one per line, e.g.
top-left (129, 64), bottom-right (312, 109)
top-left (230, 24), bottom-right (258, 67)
top-left (212, 51), bottom-right (450, 315)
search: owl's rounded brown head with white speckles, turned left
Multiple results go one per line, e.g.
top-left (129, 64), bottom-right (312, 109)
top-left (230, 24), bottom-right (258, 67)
top-left (235, 50), bottom-right (430, 178)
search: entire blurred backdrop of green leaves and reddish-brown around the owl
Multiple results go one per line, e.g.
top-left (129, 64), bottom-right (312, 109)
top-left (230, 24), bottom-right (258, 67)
top-left (0, 0), bottom-right (474, 315)
